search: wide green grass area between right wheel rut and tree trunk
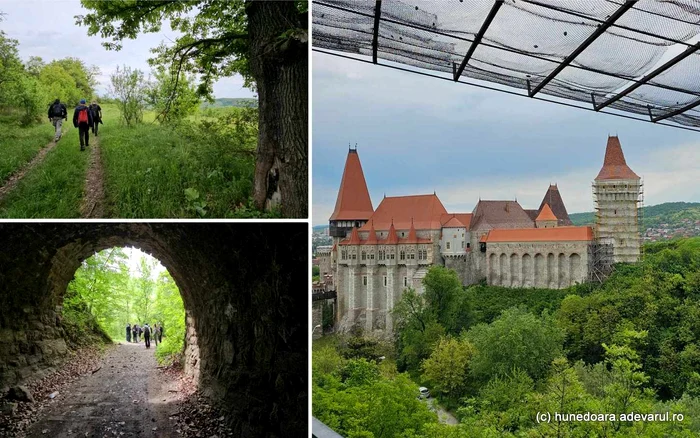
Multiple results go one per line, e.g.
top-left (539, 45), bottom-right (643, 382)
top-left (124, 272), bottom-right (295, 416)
top-left (100, 106), bottom-right (254, 218)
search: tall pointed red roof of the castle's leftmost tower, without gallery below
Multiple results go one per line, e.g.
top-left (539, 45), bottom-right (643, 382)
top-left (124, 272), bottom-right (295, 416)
top-left (330, 149), bottom-right (374, 221)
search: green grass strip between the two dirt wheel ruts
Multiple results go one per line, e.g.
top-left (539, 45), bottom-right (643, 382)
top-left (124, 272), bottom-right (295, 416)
top-left (0, 126), bottom-right (92, 218)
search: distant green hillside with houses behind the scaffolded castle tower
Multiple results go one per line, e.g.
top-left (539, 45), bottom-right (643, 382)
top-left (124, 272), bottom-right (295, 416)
top-left (569, 202), bottom-right (700, 240)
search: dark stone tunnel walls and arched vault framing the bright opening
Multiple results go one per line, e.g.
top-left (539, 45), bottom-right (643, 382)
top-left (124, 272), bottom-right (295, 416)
top-left (0, 223), bottom-right (309, 436)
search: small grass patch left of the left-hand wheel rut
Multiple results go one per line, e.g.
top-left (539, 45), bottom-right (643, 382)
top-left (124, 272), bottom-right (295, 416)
top-left (0, 119), bottom-right (54, 184)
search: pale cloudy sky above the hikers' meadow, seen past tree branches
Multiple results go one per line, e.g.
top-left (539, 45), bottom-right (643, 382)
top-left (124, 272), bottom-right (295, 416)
top-left (0, 0), bottom-right (254, 97)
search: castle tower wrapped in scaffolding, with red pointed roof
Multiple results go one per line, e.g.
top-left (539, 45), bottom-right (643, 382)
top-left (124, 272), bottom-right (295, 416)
top-left (593, 136), bottom-right (642, 263)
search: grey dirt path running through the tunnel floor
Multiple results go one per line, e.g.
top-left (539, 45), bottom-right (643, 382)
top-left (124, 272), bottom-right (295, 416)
top-left (27, 342), bottom-right (179, 437)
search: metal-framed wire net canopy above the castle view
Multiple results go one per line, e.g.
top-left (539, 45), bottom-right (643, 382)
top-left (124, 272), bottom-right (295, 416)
top-left (312, 0), bottom-right (700, 130)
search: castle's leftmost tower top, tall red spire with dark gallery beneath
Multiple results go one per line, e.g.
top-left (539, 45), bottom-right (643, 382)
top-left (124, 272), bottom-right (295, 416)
top-left (329, 148), bottom-right (374, 243)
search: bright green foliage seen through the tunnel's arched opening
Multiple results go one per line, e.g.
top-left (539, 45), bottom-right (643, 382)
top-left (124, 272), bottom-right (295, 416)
top-left (63, 248), bottom-right (185, 361)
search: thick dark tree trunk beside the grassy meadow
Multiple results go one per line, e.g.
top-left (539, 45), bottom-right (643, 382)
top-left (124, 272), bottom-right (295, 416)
top-left (246, 1), bottom-right (309, 218)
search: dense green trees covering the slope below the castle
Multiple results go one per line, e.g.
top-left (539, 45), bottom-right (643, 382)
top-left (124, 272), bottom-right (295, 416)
top-left (312, 238), bottom-right (700, 438)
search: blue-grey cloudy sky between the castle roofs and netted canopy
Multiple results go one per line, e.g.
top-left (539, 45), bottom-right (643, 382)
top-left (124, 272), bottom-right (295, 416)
top-left (312, 53), bottom-right (700, 225)
